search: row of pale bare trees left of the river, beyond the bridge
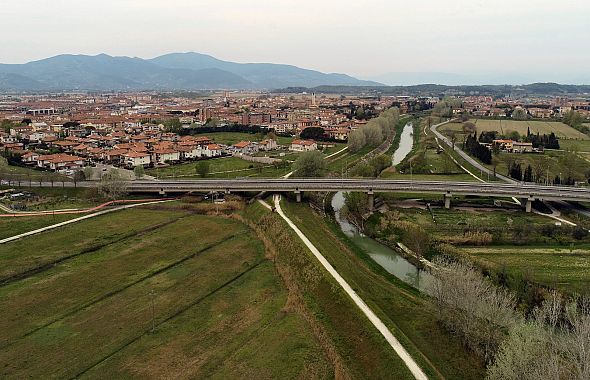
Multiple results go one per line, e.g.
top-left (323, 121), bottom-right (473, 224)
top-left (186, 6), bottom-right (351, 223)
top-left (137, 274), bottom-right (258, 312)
top-left (348, 107), bottom-right (399, 153)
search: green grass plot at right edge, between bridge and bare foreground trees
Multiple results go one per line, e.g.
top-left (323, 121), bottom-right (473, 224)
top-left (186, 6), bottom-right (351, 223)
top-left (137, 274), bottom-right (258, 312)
top-left (462, 247), bottom-right (590, 294)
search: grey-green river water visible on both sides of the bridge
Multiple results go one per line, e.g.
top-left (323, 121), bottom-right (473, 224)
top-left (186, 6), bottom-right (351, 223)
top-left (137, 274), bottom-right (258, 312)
top-left (332, 124), bottom-right (432, 291)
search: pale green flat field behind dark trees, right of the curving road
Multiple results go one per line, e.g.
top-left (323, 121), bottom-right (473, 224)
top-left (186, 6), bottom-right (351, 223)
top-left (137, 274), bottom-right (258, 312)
top-left (448, 119), bottom-right (590, 140)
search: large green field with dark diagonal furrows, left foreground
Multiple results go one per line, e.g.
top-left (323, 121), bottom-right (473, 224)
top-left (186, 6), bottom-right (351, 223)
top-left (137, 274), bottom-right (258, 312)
top-left (0, 203), bottom-right (334, 378)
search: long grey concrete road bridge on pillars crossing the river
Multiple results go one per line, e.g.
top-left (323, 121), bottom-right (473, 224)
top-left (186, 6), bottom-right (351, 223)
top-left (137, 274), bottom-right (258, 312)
top-left (121, 178), bottom-right (590, 212)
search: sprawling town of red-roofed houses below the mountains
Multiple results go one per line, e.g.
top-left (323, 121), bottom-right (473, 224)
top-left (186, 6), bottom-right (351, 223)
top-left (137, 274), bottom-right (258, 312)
top-left (0, 91), bottom-right (590, 176)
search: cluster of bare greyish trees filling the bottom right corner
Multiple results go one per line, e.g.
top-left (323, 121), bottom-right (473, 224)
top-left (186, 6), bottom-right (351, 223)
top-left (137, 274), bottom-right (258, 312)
top-left (429, 258), bottom-right (590, 380)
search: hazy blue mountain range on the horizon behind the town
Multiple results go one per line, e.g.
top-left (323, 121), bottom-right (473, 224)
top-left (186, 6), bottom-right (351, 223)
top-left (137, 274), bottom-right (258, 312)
top-left (0, 52), bottom-right (381, 91)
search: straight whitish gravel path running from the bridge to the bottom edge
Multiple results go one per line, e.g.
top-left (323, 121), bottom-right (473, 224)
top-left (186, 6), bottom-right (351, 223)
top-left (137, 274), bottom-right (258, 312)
top-left (275, 196), bottom-right (428, 380)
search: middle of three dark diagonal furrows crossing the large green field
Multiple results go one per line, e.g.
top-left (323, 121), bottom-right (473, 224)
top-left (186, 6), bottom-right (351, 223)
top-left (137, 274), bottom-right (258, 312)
top-left (0, 230), bottom-right (247, 349)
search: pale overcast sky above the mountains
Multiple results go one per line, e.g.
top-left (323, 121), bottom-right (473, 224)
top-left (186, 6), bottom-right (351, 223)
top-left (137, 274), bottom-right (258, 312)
top-left (0, 0), bottom-right (590, 82)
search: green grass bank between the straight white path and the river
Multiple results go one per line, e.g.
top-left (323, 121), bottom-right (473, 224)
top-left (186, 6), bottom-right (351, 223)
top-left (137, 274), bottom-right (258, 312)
top-left (283, 201), bottom-right (483, 379)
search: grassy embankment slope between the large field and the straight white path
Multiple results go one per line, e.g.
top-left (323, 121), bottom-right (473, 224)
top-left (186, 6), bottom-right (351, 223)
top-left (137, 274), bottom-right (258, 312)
top-left (245, 200), bottom-right (413, 379)
